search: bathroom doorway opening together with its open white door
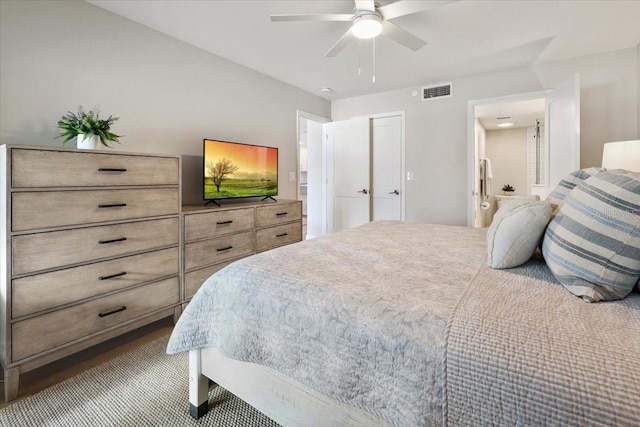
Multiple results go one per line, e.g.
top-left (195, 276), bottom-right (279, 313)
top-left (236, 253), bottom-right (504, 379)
top-left (467, 74), bottom-right (580, 227)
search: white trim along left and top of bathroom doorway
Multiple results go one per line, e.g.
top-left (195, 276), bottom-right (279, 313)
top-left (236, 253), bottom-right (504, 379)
top-left (467, 89), bottom-right (552, 227)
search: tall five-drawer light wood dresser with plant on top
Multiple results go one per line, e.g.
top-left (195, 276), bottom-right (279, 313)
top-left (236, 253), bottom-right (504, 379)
top-left (0, 145), bottom-right (181, 401)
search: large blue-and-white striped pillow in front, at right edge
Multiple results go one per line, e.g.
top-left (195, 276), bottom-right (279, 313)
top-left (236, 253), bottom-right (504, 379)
top-left (542, 169), bottom-right (640, 302)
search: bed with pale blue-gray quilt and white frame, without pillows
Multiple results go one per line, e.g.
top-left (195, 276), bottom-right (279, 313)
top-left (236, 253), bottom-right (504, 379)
top-left (167, 170), bottom-right (640, 426)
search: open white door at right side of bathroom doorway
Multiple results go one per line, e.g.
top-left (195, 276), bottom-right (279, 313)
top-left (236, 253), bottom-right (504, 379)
top-left (545, 74), bottom-right (580, 194)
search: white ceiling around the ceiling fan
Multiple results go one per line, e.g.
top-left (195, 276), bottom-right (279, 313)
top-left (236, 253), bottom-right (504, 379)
top-left (87, 0), bottom-right (640, 100)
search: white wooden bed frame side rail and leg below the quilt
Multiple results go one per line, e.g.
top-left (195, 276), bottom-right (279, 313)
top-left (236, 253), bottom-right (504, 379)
top-left (189, 348), bottom-right (390, 427)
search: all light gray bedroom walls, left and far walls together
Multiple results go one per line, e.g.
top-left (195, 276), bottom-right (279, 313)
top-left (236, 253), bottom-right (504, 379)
top-left (0, 1), bottom-right (640, 224)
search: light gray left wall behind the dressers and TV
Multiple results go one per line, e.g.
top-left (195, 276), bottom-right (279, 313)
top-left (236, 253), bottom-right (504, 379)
top-left (0, 1), bottom-right (331, 203)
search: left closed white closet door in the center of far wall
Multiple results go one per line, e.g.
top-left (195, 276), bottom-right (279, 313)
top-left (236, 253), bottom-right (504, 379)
top-left (326, 117), bottom-right (371, 232)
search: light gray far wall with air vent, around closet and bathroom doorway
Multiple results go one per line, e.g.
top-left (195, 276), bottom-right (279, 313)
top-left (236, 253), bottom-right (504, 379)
top-left (331, 47), bottom-right (640, 225)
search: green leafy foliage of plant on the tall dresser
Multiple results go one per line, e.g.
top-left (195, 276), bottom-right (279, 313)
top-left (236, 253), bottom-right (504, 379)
top-left (56, 105), bottom-right (122, 147)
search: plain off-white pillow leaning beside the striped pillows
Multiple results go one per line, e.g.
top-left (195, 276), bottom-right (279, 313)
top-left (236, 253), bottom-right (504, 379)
top-left (487, 199), bottom-right (551, 268)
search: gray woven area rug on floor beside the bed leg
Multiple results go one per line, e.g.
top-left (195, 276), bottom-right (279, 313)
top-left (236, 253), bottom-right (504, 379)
top-left (0, 336), bottom-right (278, 427)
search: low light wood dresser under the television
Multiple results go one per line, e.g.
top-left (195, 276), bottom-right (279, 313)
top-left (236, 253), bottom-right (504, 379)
top-left (182, 200), bottom-right (302, 303)
